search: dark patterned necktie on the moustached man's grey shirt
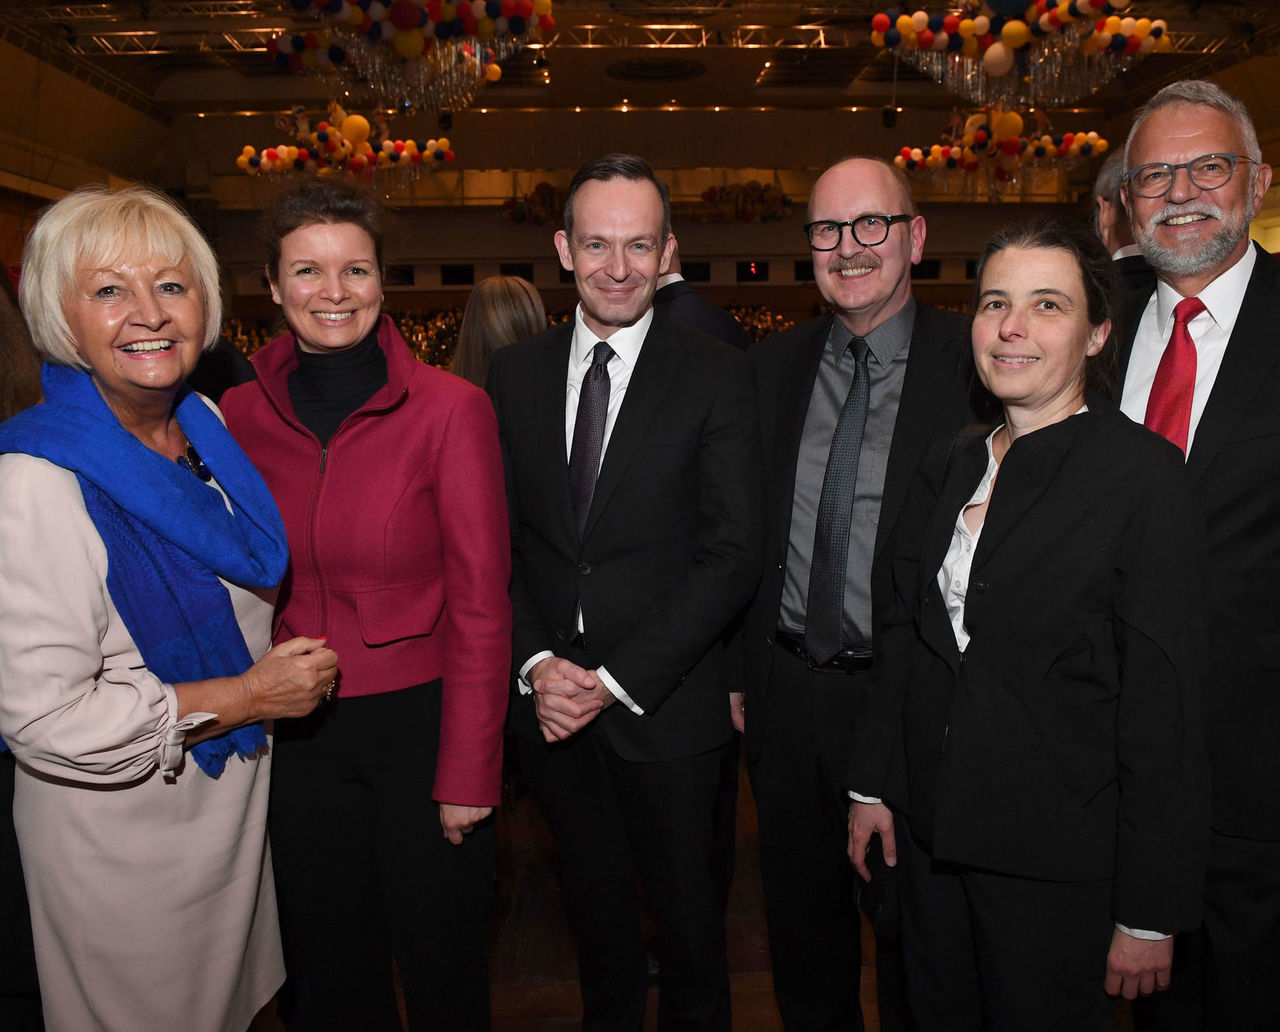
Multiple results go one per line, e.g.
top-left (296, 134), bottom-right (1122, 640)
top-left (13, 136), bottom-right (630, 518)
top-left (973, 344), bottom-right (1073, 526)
top-left (804, 337), bottom-right (870, 665)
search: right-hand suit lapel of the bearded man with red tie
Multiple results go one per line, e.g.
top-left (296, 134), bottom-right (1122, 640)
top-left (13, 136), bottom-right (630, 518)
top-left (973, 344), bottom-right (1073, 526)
top-left (1187, 245), bottom-right (1280, 479)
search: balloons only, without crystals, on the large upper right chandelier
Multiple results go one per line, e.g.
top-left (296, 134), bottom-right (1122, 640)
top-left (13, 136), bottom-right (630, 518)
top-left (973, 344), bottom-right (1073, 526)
top-left (872, 0), bottom-right (1172, 78)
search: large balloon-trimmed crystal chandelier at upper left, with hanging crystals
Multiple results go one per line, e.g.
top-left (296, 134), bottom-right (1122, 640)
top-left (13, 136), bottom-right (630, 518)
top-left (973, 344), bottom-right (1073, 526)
top-left (268, 0), bottom-right (556, 111)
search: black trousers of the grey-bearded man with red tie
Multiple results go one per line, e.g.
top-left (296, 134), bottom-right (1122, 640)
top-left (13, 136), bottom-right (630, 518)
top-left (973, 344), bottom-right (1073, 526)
top-left (1134, 831), bottom-right (1280, 1032)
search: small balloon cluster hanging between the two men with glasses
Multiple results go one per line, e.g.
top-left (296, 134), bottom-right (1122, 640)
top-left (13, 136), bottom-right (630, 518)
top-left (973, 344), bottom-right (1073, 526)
top-left (893, 110), bottom-right (1110, 182)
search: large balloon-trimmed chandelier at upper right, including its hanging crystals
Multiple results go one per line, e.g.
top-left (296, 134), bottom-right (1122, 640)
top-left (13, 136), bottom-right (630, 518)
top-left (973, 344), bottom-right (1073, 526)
top-left (872, 0), bottom-right (1172, 105)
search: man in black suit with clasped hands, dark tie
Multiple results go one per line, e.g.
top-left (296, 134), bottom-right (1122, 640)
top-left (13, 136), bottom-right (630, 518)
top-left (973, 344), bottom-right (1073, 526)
top-left (489, 155), bottom-right (760, 1032)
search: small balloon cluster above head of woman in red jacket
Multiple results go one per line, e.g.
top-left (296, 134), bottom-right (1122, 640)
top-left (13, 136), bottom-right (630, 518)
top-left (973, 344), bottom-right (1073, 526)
top-left (236, 104), bottom-right (456, 178)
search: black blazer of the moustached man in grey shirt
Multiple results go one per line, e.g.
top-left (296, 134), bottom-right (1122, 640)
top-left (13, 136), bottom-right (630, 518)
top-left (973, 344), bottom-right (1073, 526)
top-left (731, 305), bottom-right (972, 757)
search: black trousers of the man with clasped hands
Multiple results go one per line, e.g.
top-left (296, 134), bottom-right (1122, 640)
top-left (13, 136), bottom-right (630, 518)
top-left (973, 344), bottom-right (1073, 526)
top-left (517, 722), bottom-right (730, 1032)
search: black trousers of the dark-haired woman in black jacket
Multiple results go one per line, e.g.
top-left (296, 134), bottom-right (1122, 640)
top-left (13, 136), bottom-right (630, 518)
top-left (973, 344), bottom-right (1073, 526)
top-left (895, 817), bottom-right (1116, 1032)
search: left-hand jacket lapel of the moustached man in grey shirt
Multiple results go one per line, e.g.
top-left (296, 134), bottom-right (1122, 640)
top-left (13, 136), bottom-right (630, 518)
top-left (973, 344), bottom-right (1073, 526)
top-left (760, 319), bottom-right (831, 556)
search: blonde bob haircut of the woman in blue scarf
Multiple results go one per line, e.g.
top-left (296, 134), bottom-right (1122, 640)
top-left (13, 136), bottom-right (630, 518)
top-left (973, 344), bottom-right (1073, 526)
top-left (18, 186), bottom-right (223, 370)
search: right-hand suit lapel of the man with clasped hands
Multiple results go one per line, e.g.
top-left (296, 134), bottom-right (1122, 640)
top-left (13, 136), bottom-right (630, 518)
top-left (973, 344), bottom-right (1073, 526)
top-left (583, 314), bottom-right (685, 538)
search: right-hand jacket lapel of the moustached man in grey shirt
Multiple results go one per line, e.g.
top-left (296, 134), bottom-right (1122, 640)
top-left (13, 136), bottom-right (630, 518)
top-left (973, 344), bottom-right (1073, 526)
top-left (876, 305), bottom-right (965, 558)
